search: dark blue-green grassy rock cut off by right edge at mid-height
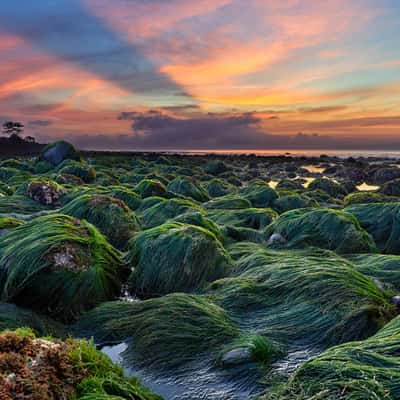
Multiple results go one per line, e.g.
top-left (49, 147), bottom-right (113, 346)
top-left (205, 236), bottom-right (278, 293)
top-left (345, 203), bottom-right (400, 254)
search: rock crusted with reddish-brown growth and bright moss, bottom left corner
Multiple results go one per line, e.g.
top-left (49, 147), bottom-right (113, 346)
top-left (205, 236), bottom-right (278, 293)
top-left (0, 330), bottom-right (161, 400)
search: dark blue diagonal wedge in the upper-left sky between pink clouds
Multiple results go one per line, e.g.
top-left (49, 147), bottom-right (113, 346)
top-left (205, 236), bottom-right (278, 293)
top-left (0, 0), bottom-right (190, 98)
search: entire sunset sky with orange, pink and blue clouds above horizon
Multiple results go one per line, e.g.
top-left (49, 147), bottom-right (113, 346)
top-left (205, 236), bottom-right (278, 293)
top-left (0, 0), bottom-right (400, 150)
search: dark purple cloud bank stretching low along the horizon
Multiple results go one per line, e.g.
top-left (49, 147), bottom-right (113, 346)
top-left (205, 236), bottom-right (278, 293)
top-left (36, 110), bottom-right (400, 150)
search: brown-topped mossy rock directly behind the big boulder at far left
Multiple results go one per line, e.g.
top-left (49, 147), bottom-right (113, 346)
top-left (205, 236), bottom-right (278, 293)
top-left (60, 194), bottom-right (140, 249)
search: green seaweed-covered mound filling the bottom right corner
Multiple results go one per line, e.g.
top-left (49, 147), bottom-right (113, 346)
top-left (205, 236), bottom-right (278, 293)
top-left (263, 317), bottom-right (400, 400)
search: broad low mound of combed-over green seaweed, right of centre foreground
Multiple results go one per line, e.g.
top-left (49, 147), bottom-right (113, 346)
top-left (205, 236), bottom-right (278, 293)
top-left (212, 243), bottom-right (396, 352)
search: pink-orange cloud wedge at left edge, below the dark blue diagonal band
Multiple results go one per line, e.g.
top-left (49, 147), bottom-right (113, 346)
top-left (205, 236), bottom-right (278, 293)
top-left (0, 36), bottom-right (132, 110)
